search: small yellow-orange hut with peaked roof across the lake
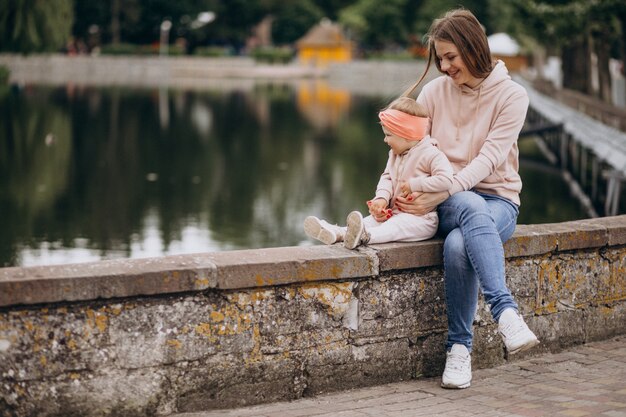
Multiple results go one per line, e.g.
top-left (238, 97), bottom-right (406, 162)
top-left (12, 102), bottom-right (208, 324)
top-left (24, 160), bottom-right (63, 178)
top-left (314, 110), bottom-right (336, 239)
top-left (296, 19), bottom-right (352, 68)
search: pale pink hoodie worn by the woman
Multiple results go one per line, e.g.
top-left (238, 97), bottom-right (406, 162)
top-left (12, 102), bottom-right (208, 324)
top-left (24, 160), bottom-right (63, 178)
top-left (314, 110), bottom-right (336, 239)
top-left (417, 61), bottom-right (528, 205)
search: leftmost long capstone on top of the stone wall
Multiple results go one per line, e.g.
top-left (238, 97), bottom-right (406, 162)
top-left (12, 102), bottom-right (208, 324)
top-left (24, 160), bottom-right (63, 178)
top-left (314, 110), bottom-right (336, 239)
top-left (0, 255), bottom-right (216, 307)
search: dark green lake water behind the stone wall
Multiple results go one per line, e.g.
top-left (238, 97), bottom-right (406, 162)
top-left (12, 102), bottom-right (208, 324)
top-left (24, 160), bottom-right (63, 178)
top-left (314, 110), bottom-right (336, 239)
top-left (0, 81), bottom-right (587, 266)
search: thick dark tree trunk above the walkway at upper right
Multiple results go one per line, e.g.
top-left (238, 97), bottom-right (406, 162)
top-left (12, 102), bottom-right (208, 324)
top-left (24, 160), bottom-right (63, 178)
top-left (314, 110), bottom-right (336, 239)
top-left (561, 32), bottom-right (592, 94)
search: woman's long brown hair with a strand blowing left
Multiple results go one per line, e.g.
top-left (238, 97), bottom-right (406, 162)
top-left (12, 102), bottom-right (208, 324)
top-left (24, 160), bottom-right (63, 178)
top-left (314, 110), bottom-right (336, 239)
top-left (402, 9), bottom-right (493, 97)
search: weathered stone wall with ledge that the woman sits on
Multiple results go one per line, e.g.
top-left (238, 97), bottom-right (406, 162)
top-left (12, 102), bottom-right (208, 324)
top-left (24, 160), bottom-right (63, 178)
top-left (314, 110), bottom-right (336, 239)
top-left (0, 216), bottom-right (626, 416)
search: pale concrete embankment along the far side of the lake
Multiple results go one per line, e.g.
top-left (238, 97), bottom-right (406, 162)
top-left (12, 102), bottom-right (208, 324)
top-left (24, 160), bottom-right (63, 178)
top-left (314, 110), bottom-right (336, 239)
top-left (0, 54), bottom-right (435, 96)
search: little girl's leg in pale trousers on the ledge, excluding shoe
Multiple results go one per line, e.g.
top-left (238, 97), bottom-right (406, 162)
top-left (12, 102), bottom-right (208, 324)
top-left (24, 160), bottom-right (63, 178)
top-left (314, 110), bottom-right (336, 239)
top-left (363, 212), bottom-right (439, 245)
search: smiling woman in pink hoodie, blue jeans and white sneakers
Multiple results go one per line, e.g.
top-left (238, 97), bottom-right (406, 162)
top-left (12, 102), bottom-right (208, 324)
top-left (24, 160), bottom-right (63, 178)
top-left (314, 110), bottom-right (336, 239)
top-left (396, 9), bottom-right (539, 388)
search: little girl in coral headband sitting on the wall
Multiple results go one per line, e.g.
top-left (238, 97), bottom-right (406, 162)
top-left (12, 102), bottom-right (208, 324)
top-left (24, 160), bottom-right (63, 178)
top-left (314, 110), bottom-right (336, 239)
top-left (304, 97), bottom-right (453, 249)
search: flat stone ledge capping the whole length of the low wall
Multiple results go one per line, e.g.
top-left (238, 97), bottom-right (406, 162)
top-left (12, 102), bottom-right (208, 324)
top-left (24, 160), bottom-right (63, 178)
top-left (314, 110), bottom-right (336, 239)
top-left (0, 215), bottom-right (626, 307)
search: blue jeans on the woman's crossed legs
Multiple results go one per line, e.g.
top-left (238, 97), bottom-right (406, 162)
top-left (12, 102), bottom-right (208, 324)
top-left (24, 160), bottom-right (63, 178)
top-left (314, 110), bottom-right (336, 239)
top-left (438, 191), bottom-right (519, 352)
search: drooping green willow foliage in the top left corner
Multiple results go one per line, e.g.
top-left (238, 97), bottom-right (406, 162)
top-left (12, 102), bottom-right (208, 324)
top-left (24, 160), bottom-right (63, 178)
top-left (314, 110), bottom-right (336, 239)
top-left (0, 0), bottom-right (74, 53)
